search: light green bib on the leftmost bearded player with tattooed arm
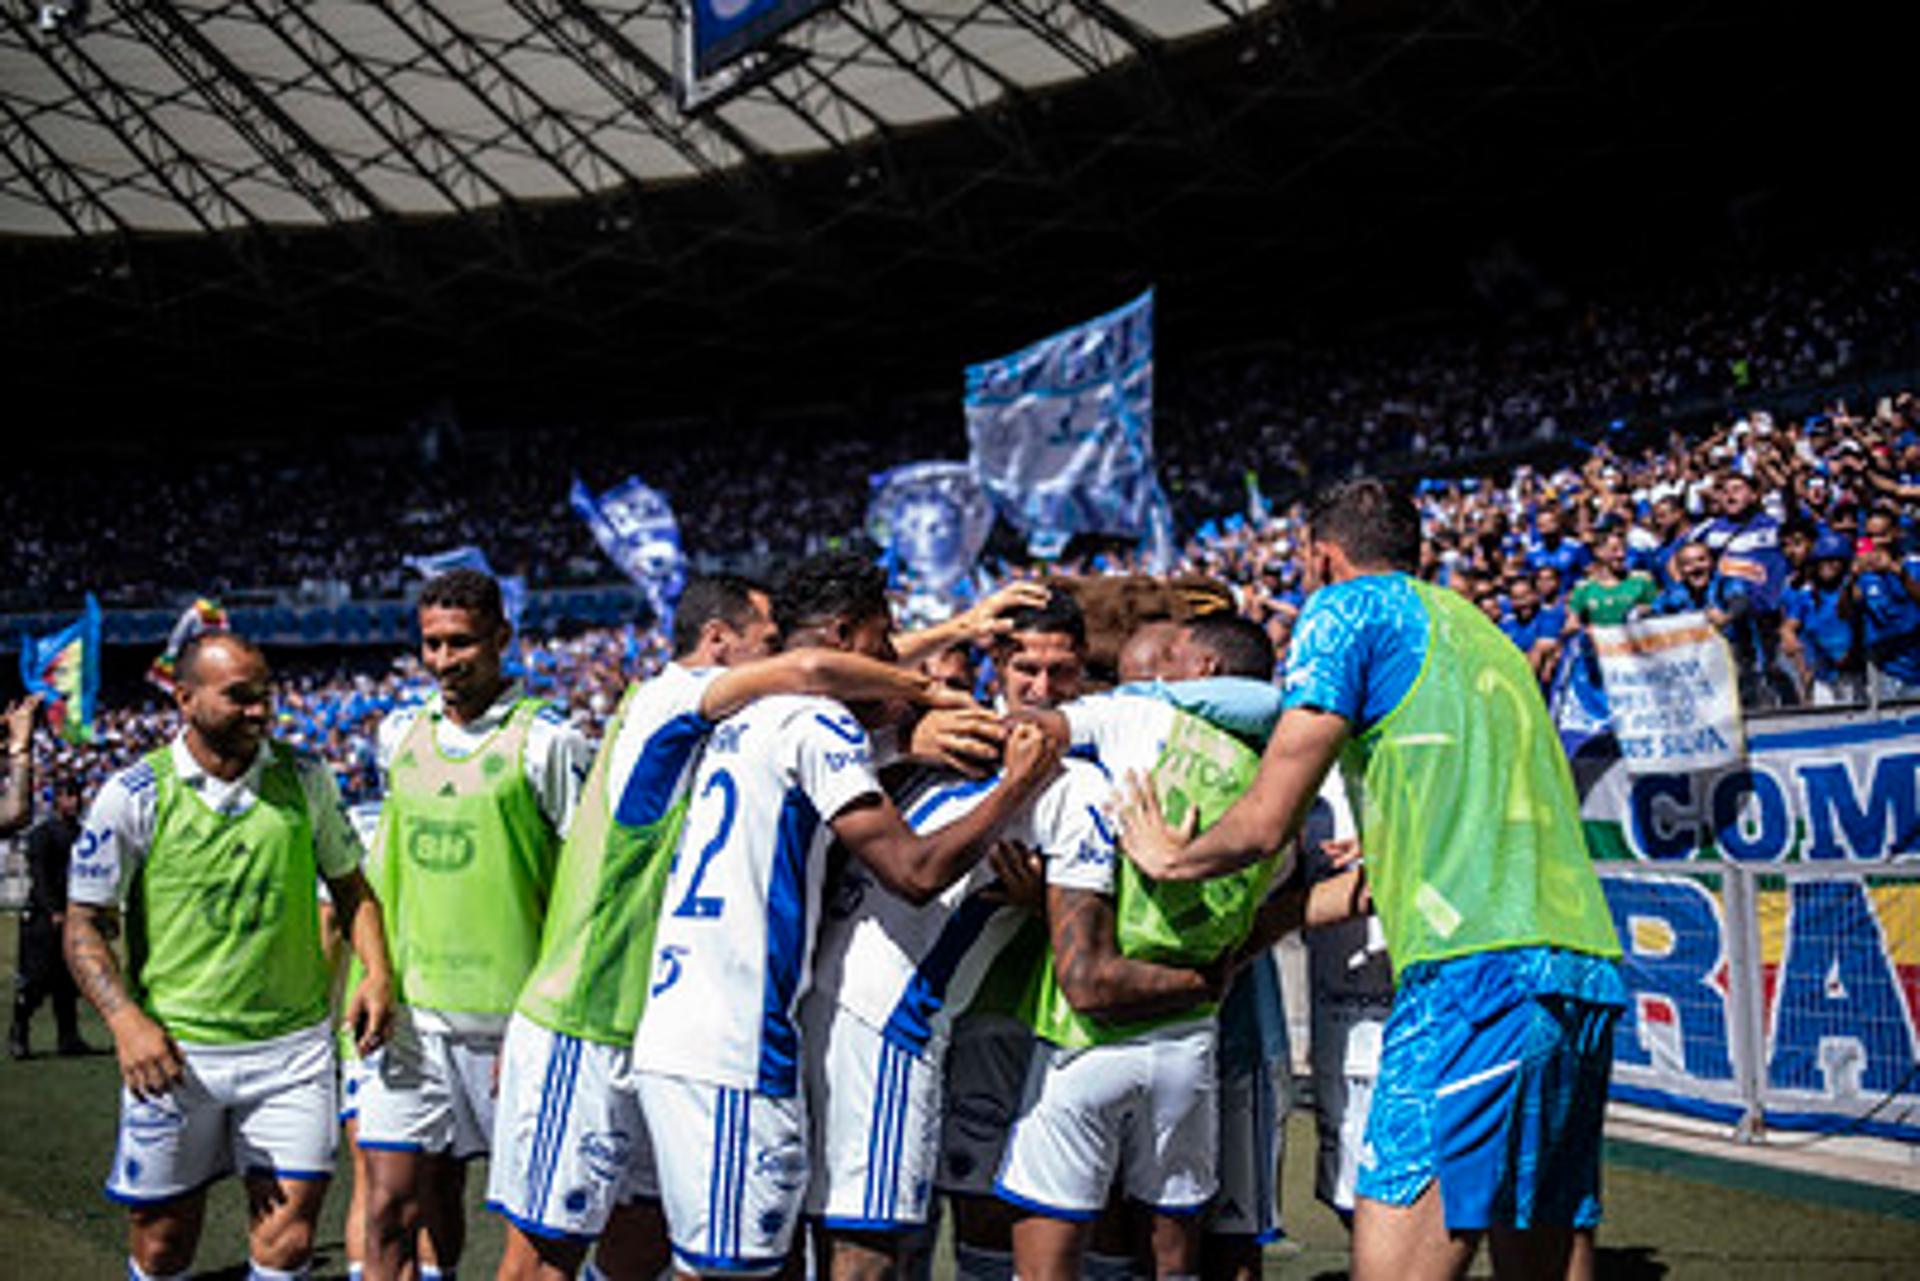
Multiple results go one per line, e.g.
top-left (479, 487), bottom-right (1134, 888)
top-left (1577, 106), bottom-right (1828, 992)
top-left (127, 743), bottom-right (326, 1045)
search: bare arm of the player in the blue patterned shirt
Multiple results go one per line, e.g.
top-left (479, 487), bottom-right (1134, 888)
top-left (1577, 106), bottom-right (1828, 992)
top-left (1117, 707), bottom-right (1348, 882)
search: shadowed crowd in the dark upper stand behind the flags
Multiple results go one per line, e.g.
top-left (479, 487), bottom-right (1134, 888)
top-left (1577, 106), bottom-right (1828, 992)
top-left (0, 248), bottom-right (1920, 609)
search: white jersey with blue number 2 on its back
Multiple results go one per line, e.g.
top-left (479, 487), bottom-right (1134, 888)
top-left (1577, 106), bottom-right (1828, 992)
top-left (634, 695), bottom-right (879, 1097)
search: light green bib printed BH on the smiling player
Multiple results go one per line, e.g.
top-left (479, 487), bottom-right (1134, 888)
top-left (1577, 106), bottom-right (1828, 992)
top-left (378, 699), bottom-right (559, 1014)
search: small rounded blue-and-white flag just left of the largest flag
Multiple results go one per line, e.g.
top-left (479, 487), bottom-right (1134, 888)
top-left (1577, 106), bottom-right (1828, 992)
top-left (866, 463), bottom-right (993, 603)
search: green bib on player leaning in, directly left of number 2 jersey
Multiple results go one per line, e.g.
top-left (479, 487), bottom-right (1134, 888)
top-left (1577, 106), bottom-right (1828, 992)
top-left (518, 686), bottom-right (687, 1045)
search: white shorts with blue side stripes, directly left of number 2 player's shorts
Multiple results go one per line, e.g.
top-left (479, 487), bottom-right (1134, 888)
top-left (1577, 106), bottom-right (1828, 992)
top-left (486, 1014), bottom-right (659, 1241)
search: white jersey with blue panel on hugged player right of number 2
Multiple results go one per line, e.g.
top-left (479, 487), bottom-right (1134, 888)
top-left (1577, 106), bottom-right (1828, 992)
top-left (814, 761), bottom-right (1114, 1054)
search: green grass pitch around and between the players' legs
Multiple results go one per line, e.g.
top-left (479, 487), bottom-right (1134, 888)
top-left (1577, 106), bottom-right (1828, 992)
top-left (0, 916), bottom-right (1920, 1281)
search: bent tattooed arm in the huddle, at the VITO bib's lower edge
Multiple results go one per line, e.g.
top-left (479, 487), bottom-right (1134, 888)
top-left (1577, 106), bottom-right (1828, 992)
top-left (1046, 885), bottom-right (1225, 1022)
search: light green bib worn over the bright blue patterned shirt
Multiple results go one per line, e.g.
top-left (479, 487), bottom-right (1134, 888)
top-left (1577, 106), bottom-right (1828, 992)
top-left (1342, 580), bottom-right (1620, 972)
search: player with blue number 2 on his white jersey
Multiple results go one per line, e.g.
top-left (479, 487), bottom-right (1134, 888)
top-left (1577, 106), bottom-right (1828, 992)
top-left (632, 553), bottom-right (1054, 1275)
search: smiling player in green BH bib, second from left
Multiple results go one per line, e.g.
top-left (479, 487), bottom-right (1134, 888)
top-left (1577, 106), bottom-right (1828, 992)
top-left (359, 568), bottom-right (591, 1281)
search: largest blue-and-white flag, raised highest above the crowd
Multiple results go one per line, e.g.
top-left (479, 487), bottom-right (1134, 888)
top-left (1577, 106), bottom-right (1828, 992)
top-left (966, 290), bottom-right (1156, 547)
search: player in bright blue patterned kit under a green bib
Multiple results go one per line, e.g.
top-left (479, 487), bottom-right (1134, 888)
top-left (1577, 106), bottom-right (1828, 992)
top-left (1121, 480), bottom-right (1626, 1281)
